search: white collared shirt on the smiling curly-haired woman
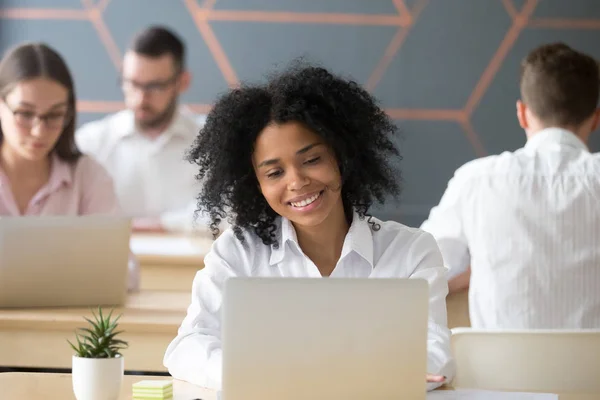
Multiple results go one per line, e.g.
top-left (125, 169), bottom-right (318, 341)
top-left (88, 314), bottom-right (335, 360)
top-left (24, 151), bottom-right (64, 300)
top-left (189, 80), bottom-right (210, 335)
top-left (164, 214), bottom-right (454, 389)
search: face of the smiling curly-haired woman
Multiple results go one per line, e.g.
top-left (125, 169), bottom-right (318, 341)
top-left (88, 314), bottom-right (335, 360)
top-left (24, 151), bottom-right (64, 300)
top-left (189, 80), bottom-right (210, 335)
top-left (252, 122), bottom-right (348, 242)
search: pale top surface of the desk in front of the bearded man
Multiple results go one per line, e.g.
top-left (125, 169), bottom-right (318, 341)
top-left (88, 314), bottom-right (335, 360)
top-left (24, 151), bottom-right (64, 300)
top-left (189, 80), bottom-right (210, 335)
top-left (129, 233), bottom-right (214, 266)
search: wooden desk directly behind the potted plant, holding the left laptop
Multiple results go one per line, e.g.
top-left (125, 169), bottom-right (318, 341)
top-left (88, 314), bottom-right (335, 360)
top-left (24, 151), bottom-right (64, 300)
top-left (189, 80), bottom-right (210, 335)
top-left (0, 291), bottom-right (190, 372)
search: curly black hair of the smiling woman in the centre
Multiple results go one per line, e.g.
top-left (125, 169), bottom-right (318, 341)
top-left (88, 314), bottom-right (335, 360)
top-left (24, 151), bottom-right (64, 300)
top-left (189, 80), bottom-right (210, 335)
top-left (187, 64), bottom-right (401, 246)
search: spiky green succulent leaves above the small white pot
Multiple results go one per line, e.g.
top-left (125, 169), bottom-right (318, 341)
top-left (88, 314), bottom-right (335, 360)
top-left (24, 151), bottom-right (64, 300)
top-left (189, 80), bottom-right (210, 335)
top-left (67, 307), bottom-right (128, 358)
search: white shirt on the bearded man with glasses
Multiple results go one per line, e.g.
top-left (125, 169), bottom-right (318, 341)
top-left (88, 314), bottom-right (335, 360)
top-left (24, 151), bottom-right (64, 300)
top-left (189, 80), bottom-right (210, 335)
top-left (76, 108), bottom-right (204, 231)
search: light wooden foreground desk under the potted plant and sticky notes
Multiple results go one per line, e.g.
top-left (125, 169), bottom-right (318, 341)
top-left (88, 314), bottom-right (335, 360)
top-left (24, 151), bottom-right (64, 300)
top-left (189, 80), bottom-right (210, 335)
top-left (0, 373), bottom-right (598, 400)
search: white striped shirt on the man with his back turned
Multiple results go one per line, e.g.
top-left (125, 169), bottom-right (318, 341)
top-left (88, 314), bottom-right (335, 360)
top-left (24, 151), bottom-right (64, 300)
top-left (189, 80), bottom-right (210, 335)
top-left (421, 128), bottom-right (600, 329)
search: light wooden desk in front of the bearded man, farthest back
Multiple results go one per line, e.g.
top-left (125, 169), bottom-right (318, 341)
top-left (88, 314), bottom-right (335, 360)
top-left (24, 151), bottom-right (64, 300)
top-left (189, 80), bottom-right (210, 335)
top-left (130, 233), bottom-right (213, 293)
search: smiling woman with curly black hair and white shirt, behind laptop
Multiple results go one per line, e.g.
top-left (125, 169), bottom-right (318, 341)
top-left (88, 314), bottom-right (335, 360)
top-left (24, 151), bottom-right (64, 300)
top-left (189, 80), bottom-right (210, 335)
top-left (164, 65), bottom-right (454, 389)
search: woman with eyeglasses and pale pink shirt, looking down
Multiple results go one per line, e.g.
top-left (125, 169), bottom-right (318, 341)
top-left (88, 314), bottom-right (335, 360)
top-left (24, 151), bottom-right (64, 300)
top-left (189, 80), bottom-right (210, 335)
top-left (0, 43), bottom-right (137, 288)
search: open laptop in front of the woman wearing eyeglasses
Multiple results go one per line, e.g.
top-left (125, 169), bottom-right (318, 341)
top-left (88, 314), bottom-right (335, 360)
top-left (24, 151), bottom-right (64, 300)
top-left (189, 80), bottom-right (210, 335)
top-left (0, 216), bottom-right (131, 308)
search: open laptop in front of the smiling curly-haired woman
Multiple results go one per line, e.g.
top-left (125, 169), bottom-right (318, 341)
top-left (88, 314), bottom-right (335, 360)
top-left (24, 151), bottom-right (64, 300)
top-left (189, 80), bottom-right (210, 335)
top-left (220, 278), bottom-right (429, 400)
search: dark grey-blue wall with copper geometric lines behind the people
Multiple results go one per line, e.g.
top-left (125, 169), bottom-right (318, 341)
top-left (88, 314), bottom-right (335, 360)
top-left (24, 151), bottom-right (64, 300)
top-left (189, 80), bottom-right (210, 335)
top-left (0, 0), bottom-right (600, 225)
